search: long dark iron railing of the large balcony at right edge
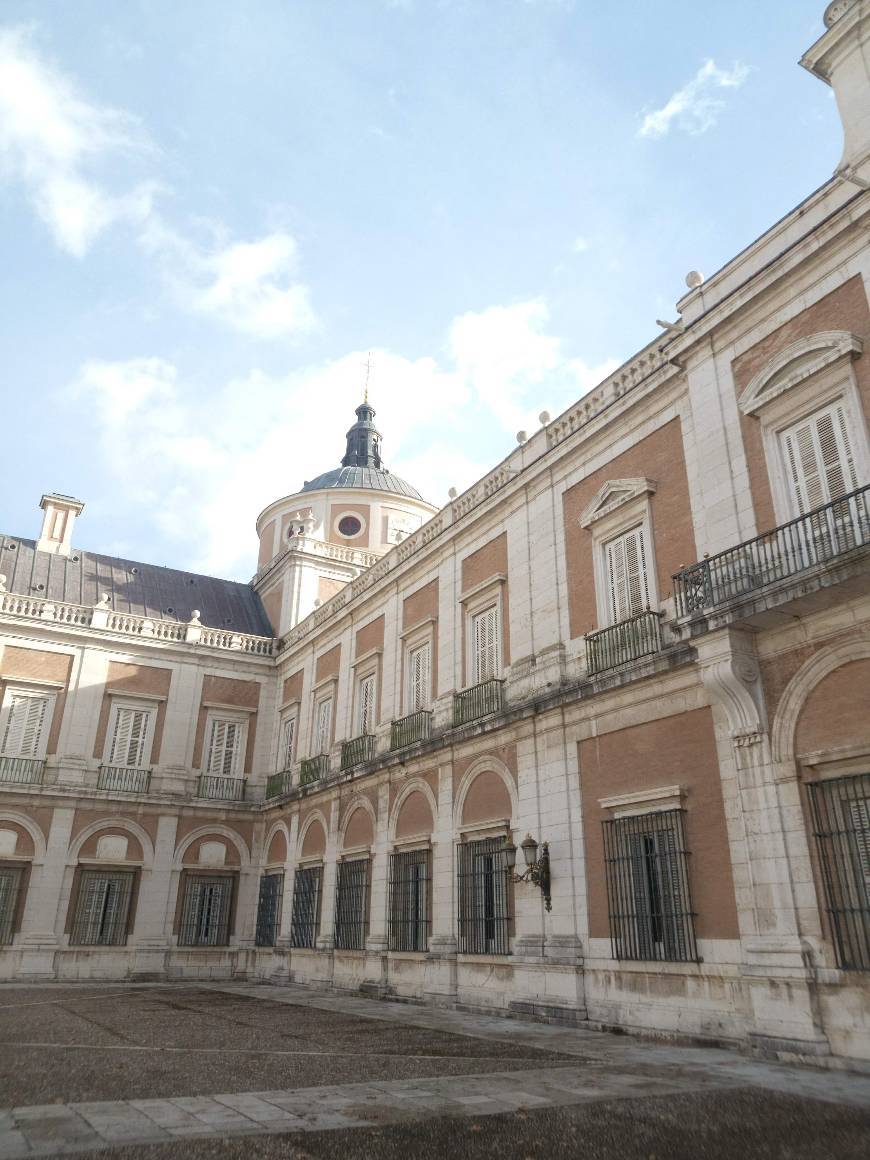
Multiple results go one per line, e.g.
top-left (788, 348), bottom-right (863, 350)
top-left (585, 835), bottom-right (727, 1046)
top-left (674, 485), bottom-right (870, 616)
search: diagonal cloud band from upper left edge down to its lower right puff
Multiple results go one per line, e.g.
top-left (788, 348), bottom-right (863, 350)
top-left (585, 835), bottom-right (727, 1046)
top-left (0, 28), bottom-right (316, 339)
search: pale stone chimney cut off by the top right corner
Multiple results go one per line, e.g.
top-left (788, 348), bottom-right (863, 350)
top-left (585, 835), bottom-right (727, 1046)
top-left (800, 0), bottom-right (870, 189)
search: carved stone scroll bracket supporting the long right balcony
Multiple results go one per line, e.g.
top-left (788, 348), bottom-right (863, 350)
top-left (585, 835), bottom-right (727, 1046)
top-left (697, 629), bottom-right (768, 749)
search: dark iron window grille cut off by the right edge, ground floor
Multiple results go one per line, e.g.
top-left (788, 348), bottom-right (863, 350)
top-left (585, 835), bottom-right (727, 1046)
top-left (807, 774), bottom-right (870, 971)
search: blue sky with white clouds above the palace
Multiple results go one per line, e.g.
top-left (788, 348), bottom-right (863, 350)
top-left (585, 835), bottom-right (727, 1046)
top-left (0, 0), bottom-right (842, 580)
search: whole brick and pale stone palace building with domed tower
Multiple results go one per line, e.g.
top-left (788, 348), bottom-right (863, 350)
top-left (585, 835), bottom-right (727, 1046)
top-left (0, 0), bottom-right (870, 1061)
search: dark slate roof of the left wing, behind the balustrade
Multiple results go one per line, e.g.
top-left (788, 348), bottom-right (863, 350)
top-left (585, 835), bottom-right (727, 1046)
top-left (0, 534), bottom-right (274, 637)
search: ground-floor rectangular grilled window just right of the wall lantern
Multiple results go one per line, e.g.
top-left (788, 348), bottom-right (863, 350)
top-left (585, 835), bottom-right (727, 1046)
top-left (603, 810), bottom-right (698, 963)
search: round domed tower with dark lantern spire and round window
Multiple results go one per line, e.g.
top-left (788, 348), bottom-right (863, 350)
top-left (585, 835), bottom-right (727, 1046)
top-left (254, 397), bottom-right (437, 636)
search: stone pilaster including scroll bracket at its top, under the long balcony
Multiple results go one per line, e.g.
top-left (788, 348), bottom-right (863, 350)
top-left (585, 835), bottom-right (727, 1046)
top-left (696, 628), bottom-right (829, 1054)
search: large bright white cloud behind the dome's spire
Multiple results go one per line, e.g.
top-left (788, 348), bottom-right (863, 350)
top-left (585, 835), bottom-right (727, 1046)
top-left (71, 302), bottom-right (616, 578)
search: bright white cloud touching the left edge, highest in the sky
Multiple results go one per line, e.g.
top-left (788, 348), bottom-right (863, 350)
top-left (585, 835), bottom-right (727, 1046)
top-left (0, 28), bottom-right (155, 258)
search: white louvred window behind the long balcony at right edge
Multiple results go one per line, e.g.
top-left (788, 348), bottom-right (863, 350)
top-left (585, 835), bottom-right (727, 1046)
top-left (781, 400), bottom-right (858, 516)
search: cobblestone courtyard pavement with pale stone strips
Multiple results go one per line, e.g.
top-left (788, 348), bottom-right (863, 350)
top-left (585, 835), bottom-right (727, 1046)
top-left (0, 984), bottom-right (870, 1160)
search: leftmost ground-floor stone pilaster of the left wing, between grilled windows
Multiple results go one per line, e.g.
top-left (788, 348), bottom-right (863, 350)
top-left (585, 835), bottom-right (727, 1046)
top-left (19, 807), bottom-right (75, 979)
